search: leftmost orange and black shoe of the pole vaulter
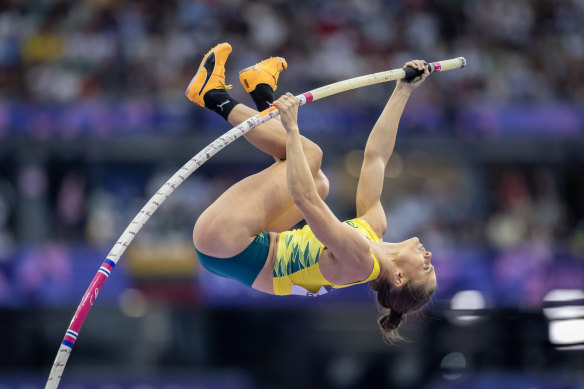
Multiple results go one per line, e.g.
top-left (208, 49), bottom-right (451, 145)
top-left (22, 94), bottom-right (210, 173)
top-left (185, 43), bottom-right (232, 108)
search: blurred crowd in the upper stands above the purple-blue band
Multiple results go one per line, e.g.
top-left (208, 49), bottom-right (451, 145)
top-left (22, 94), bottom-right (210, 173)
top-left (0, 0), bottom-right (584, 104)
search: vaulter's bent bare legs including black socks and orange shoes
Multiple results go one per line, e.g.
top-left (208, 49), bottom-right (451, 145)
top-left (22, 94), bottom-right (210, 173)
top-left (186, 43), bottom-right (328, 257)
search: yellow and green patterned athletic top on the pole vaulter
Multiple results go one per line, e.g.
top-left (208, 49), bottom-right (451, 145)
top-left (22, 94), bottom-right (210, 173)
top-left (273, 219), bottom-right (380, 296)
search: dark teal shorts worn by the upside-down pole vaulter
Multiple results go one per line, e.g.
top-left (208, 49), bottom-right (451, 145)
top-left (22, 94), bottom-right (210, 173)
top-left (195, 231), bottom-right (270, 287)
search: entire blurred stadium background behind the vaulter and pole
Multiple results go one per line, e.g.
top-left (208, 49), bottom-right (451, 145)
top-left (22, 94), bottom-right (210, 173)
top-left (0, 0), bottom-right (584, 389)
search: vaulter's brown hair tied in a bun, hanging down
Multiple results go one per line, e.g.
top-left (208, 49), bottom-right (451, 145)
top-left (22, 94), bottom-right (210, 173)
top-left (369, 277), bottom-right (436, 343)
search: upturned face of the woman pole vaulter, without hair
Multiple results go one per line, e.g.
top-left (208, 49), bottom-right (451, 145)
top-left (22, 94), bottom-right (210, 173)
top-left (396, 238), bottom-right (436, 290)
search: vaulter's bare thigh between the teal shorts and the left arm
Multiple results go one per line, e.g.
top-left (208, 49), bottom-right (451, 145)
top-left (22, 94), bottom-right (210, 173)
top-left (193, 161), bottom-right (293, 257)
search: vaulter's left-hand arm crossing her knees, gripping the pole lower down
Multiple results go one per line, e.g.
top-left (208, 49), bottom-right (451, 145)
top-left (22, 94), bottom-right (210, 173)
top-left (274, 93), bottom-right (371, 282)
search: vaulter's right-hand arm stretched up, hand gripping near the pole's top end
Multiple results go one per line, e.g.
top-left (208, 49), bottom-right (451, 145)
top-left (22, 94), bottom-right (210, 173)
top-left (356, 60), bottom-right (430, 237)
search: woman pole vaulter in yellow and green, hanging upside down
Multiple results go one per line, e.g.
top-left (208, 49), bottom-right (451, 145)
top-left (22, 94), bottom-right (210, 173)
top-left (186, 43), bottom-right (436, 341)
